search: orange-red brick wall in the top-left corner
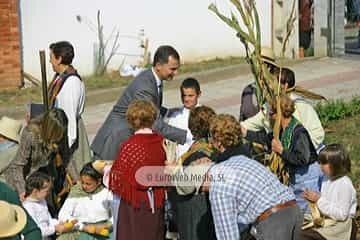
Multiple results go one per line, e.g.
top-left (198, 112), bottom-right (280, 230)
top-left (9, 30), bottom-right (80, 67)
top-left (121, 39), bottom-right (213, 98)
top-left (0, 0), bottom-right (22, 89)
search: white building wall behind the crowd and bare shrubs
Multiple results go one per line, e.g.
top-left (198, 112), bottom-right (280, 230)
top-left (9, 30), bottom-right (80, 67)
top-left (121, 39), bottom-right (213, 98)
top-left (20, 0), bottom-right (271, 77)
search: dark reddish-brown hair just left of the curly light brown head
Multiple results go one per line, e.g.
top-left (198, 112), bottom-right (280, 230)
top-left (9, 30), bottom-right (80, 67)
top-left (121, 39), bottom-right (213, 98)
top-left (189, 106), bottom-right (216, 140)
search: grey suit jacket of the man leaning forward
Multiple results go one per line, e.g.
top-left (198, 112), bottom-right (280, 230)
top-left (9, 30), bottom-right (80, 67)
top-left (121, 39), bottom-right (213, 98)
top-left (91, 69), bottom-right (186, 160)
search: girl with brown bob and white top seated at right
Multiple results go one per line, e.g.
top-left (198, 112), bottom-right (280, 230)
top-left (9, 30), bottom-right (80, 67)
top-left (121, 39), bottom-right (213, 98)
top-left (301, 144), bottom-right (357, 240)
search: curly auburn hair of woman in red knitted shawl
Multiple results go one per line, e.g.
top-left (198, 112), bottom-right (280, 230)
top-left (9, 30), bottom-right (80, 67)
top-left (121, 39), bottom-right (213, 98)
top-left (126, 100), bottom-right (157, 131)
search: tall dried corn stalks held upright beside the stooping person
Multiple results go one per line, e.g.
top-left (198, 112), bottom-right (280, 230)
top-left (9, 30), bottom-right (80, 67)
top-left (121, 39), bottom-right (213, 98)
top-left (209, 0), bottom-right (288, 184)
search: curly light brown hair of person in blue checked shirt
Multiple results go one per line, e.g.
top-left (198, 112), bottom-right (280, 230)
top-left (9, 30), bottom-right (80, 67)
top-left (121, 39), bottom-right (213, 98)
top-left (210, 114), bottom-right (241, 148)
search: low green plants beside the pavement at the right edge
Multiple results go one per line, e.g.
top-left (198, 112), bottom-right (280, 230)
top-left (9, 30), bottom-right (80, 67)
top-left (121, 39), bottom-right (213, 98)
top-left (316, 96), bottom-right (360, 127)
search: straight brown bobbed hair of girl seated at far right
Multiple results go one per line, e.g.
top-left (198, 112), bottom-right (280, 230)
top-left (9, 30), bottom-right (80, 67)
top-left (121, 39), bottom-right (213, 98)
top-left (319, 143), bottom-right (351, 179)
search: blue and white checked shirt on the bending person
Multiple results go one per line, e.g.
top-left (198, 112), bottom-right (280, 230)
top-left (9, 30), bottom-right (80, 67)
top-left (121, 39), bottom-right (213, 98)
top-left (209, 155), bottom-right (295, 240)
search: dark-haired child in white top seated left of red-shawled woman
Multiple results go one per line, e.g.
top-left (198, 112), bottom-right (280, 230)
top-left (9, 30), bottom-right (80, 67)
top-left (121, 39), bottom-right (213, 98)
top-left (58, 163), bottom-right (113, 240)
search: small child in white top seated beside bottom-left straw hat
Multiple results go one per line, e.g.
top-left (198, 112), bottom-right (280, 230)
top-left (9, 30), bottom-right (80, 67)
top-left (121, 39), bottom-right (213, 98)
top-left (23, 172), bottom-right (71, 239)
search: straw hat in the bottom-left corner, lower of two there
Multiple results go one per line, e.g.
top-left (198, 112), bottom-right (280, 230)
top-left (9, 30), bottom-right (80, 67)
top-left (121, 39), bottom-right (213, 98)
top-left (0, 201), bottom-right (26, 238)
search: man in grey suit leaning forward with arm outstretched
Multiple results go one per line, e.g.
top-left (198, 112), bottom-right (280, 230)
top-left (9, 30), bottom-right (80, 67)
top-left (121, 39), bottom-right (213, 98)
top-left (91, 46), bottom-right (190, 160)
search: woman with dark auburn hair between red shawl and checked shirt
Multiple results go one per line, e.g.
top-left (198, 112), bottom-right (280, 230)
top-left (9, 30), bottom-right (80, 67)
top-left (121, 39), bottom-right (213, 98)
top-left (166, 106), bottom-right (216, 240)
